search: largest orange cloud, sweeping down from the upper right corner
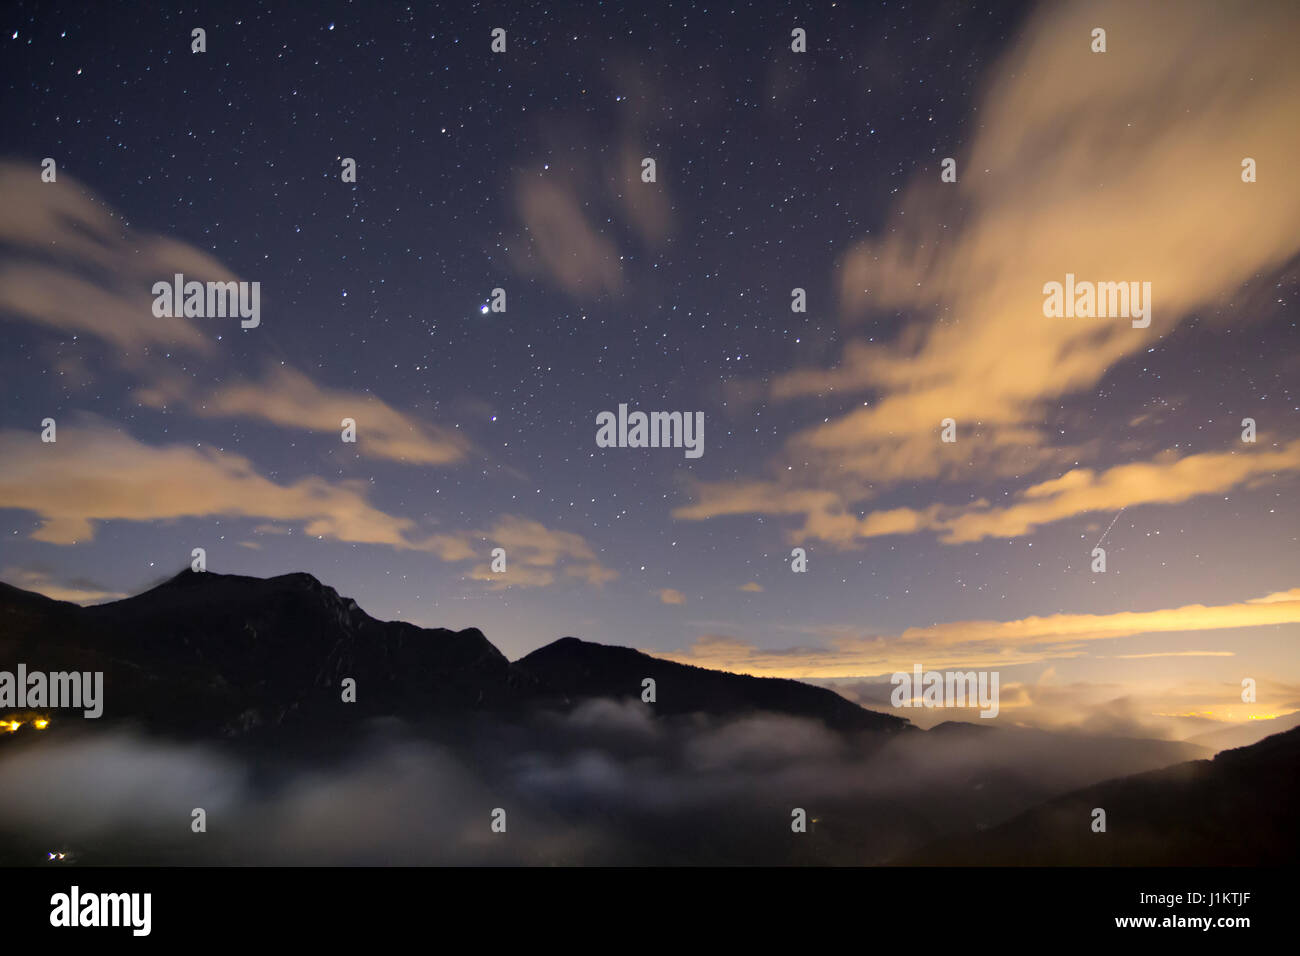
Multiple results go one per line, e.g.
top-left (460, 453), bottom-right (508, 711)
top-left (675, 0), bottom-right (1300, 546)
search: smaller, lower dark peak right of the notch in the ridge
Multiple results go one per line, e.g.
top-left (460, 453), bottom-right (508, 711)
top-left (516, 637), bottom-right (911, 732)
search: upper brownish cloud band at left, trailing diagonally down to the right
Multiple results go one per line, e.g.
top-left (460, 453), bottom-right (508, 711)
top-left (0, 161), bottom-right (469, 473)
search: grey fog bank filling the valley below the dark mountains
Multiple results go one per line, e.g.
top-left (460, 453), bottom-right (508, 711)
top-left (0, 700), bottom-right (1211, 865)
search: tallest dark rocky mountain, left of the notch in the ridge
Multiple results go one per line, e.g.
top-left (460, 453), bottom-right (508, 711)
top-left (0, 571), bottom-right (512, 734)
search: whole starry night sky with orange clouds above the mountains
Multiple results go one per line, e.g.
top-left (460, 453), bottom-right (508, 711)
top-left (0, 1), bottom-right (1300, 736)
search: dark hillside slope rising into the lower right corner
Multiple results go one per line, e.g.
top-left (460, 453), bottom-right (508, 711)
top-left (898, 728), bottom-right (1300, 866)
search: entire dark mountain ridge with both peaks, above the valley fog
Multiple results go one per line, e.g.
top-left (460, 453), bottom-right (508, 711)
top-left (0, 570), bottom-right (910, 735)
